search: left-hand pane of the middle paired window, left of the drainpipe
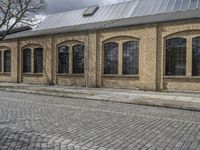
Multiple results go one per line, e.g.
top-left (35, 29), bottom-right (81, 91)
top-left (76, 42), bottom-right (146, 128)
top-left (58, 46), bottom-right (69, 73)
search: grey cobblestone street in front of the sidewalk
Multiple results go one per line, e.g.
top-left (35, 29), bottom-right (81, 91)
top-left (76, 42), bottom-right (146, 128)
top-left (0, 92), bottom-right (200, 150)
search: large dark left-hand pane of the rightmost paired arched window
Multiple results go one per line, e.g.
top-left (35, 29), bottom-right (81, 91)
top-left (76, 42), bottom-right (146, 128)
top-left (166, 38), bottom-right (186, 76)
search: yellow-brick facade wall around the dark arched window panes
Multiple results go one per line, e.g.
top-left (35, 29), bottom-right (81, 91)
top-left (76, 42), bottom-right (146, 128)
top-left (0, 20), bottom-right (200, 91)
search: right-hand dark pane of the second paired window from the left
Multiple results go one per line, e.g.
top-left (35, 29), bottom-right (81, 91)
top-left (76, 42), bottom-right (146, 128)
top-left (34, 48), bottom-right (43, 73)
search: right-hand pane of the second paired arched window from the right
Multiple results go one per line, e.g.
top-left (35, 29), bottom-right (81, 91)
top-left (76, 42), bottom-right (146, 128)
top-left (123, 41), bottom-right (139, 75)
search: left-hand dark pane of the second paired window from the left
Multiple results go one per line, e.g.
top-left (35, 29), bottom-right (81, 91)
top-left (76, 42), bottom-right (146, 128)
top-left (23, 48), bottom-right (31, 73)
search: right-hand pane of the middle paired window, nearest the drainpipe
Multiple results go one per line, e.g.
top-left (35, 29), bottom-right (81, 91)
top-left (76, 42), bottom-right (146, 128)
top-left (72, 44), bottom-right (84, 74)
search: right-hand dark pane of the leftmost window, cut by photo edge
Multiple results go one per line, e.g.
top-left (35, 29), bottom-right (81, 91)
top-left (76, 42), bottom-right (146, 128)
top-left (4, 50), bottom-right (11, 72)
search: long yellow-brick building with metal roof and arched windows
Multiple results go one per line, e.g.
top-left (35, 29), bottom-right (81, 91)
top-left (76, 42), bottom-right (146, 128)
top-left (0, 0), bottom-right (200, 91)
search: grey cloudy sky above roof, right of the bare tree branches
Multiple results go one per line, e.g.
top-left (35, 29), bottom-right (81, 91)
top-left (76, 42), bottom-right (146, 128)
top-left (46, 0), bottom-right (127, 14)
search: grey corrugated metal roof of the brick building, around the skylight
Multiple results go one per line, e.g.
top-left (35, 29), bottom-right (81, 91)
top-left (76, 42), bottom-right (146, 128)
top-left (7, 0), bottom-right (200, 38)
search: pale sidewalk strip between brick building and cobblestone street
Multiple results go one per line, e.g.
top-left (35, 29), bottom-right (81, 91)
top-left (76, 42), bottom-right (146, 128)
top-left (0, 83), bottom-right (200, 111)
